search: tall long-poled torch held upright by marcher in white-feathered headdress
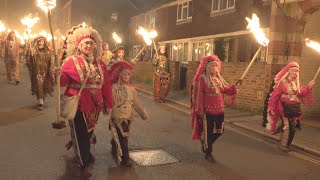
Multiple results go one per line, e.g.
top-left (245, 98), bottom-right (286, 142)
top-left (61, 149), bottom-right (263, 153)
top-left (37, 0), bottom-right (66, 129)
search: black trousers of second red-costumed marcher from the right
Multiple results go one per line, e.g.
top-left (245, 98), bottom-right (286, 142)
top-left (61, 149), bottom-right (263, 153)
top-left (206, 114), bottom-right (224, 154)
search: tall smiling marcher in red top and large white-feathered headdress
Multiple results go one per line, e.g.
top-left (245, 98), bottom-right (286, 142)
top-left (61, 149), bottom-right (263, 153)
top-left (56, 25), bottom-right (113, 173)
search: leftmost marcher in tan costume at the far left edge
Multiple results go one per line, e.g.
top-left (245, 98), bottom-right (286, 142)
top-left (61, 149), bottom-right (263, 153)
top-left (4, 31), bottom-right (20, 84)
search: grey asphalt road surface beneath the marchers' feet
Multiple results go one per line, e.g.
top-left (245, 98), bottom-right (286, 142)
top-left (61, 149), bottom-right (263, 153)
top-left (0, 63), bottom-right (320, 180)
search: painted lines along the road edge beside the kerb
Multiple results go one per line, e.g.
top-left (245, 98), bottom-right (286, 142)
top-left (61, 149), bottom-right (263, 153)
top-left (140, 93), bottom-right (320, 165)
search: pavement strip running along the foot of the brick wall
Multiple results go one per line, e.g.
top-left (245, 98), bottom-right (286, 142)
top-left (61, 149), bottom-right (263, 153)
top-left (134, 82), bottom-right (320, 157)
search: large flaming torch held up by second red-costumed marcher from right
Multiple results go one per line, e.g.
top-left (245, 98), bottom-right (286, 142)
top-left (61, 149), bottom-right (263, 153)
top-left (237, 14), bottom-right (269, 85)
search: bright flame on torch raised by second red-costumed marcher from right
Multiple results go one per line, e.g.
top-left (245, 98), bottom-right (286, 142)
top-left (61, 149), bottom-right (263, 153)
top-left (246, 14), bottom-right (269, 46)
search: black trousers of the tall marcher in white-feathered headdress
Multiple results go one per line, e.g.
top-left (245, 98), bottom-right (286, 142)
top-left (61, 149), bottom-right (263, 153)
top-left (72, 112), bottom-right (93, 167)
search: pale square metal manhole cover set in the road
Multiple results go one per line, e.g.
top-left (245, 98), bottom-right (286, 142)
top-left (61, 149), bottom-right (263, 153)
top-left (129, 149), bottom-right (179, 166)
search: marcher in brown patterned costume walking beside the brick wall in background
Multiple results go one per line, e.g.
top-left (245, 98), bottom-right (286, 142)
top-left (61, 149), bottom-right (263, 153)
top-left (153, 45), bottom-right (171, 103)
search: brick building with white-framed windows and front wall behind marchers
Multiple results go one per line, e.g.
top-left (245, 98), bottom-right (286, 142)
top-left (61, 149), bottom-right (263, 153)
top-left (129, 0), bottom-right (320, 116)
